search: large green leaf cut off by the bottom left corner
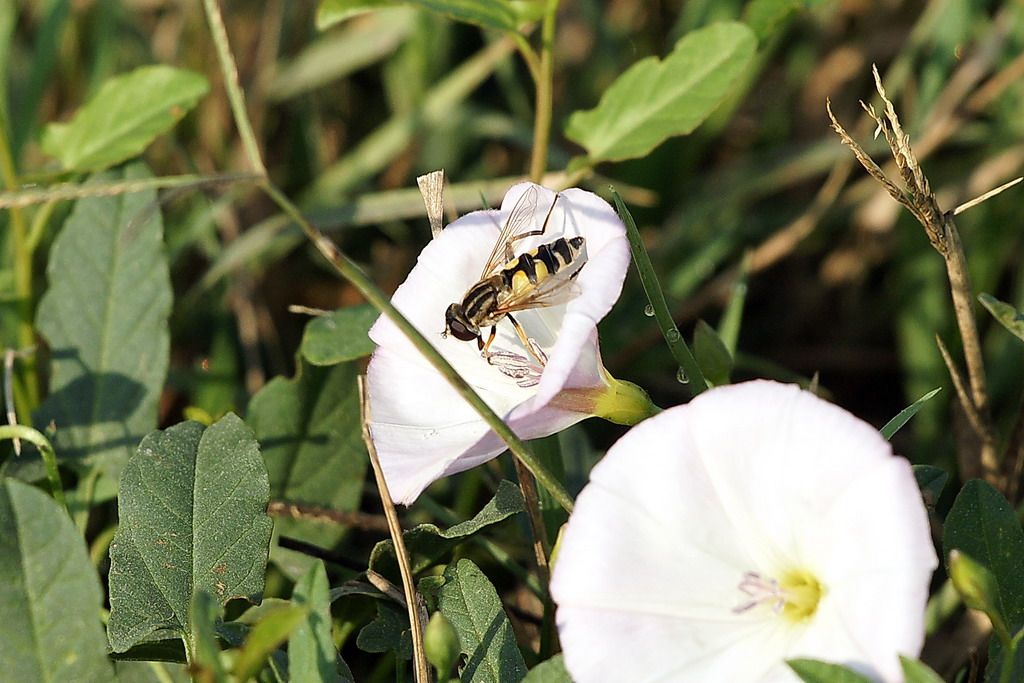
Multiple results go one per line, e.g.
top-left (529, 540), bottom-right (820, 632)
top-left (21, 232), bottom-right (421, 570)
top-left (0, 479), bottom-right (114, 683)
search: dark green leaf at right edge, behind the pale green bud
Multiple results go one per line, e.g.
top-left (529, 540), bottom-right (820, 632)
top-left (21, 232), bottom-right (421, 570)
top-left (942, 479), bottom-right (1024, 632)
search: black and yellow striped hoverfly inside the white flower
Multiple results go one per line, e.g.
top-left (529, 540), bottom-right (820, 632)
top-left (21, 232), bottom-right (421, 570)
top-left (441, 185), bottom-right (586, 367)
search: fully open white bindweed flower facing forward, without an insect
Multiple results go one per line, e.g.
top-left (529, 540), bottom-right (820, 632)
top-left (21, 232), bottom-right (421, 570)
top-left (551, 381), bottom-right (936, 683)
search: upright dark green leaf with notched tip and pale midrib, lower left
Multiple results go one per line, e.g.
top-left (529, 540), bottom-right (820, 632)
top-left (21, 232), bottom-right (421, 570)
top-left (108, 414), bottom-right (272, 652)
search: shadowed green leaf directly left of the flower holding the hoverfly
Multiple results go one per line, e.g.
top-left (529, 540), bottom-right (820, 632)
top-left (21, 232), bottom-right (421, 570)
top-left (248, 360), bottom-right (369, 547)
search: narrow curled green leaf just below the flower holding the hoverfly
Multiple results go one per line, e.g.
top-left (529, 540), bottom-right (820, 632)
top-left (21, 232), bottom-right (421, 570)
top-left (370, 480), bottom-right (525, 577)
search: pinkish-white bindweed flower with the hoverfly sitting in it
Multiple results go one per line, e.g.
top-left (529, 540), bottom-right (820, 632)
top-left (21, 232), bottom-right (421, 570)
top-left (367, 183), bottom-right (649, 505)
